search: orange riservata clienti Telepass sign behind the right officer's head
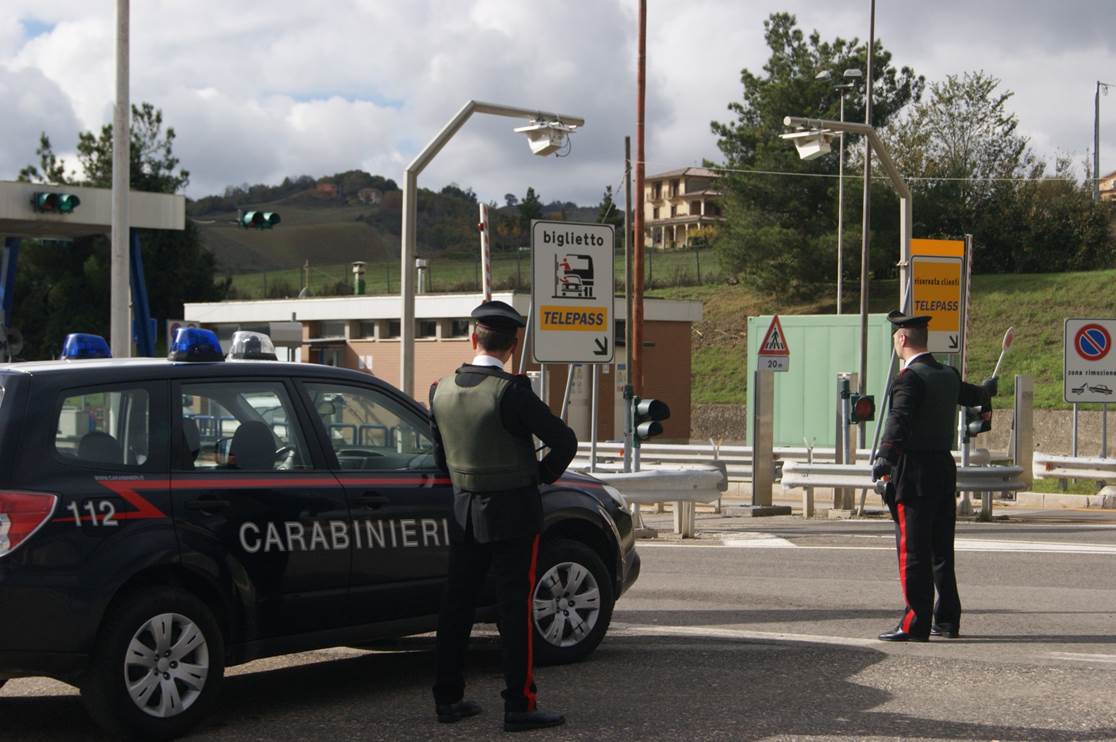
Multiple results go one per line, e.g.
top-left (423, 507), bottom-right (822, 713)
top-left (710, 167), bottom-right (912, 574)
top-left (911, 256), bottom-right (963, 353)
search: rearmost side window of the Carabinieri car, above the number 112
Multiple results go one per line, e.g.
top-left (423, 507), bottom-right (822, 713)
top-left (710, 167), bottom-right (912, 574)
top-left (55, 388), bottom-right (151, 468)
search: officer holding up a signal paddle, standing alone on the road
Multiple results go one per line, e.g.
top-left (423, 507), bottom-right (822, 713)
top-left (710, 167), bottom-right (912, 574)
top-left (872, 310), bottom-right (995, 642)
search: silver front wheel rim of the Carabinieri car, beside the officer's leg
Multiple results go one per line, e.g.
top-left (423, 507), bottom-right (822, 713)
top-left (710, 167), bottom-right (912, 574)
top-left (532, 561), bottom-right (600, 647)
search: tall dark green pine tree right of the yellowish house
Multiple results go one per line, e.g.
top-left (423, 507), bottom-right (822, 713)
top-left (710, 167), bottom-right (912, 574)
top-left (712, 13), bottom-right (924, 290)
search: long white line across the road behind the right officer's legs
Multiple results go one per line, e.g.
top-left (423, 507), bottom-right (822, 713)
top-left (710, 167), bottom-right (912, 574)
top-left (637, 532), bottom-right (1116, 555)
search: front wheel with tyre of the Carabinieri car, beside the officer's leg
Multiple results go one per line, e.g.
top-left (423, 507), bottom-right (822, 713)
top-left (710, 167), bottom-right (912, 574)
top-left (531, 539), bottom-right (614, 665)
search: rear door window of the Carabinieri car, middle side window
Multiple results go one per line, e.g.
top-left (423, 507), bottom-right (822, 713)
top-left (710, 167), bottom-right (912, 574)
top-left (175, 380), bottom-right (312, 471)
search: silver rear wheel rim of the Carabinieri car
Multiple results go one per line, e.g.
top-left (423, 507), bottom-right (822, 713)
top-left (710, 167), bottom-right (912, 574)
top-left (124, 614), bottom-right (210, 719)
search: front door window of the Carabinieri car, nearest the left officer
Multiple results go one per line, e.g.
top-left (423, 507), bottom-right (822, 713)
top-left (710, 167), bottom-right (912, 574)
top-left (305, 383), bottom-right (434, 471)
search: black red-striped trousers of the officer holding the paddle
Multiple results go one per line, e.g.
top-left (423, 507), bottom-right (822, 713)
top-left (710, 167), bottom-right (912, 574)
top-left (887, 453), bottom-right (961, 636)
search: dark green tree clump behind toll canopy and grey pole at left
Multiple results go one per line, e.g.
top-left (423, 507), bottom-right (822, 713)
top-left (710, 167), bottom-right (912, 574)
top-left (13, 103), bottom-right (230, 358)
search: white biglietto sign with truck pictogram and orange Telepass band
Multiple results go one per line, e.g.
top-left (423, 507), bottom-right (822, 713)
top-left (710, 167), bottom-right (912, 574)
top-left (531, 220), bottom-right (615, 364)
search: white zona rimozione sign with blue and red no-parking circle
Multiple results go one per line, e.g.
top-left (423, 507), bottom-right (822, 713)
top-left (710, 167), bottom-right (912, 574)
top-left (1062, 319), bottom-right (1116, 402)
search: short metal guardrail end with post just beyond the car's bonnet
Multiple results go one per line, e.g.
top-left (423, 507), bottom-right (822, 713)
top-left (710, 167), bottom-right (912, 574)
top-left (594, 466), bottom-right (725, 538)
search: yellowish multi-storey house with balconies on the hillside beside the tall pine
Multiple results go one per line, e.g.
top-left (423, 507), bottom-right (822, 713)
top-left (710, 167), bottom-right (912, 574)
top-left (643, 167), bottom-right (724, 250)
